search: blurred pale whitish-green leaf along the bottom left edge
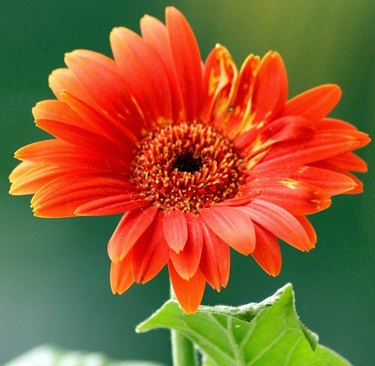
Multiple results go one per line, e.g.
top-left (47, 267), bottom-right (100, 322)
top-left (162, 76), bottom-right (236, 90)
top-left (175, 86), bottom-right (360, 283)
top-left (4, 346), bottom-right (166, 366)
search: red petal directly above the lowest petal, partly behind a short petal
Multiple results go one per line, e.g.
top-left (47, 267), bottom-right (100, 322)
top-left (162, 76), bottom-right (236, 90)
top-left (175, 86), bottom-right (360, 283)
top-left (169, 214), bottom-right (203, 280)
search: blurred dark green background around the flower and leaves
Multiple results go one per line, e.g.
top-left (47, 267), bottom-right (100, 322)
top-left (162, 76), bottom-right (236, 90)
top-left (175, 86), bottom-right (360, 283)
top-left (0, 0), bottom-right (375, 365)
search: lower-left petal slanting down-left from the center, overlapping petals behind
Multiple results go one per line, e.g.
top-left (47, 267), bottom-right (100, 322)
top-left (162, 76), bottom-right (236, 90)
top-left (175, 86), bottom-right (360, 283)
top-left (108, 206), bottom-right (158, 263)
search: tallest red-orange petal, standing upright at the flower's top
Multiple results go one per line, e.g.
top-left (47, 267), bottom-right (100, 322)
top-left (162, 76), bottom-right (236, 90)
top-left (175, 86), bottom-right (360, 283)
top-left (166, 6), bottom-right (202, 121)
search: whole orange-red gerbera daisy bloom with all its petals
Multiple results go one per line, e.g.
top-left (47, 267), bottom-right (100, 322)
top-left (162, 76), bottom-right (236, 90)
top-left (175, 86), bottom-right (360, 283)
top-left (10, 7), bottom-right (369, 313)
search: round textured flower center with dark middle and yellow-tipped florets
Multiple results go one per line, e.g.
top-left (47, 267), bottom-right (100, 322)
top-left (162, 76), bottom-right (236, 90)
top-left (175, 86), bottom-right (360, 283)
top-left (130, 122), bottom-right (244, 213)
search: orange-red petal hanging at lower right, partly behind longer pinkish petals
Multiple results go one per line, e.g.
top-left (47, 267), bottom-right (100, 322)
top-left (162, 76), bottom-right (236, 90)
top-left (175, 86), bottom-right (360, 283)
top-left (251, 224), bottom-right (282, 276)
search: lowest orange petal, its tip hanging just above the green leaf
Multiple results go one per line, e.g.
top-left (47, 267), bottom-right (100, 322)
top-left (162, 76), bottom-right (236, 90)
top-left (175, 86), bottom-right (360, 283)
top-left (168, 262), bottom-right (206, 314)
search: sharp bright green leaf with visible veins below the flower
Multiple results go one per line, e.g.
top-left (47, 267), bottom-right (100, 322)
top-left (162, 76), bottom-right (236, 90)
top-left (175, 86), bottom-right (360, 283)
top-left (137, 284), bottom-right (350, 366)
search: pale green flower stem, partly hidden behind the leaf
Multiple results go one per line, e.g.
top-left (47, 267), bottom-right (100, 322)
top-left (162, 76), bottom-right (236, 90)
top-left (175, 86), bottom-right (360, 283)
top-left (171, 284), bottom-right (197, 366)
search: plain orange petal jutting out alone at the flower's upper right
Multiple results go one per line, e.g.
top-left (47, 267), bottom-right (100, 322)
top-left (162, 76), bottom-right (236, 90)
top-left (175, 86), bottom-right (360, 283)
top-left (282, 84), bottom-right (341, 121)
